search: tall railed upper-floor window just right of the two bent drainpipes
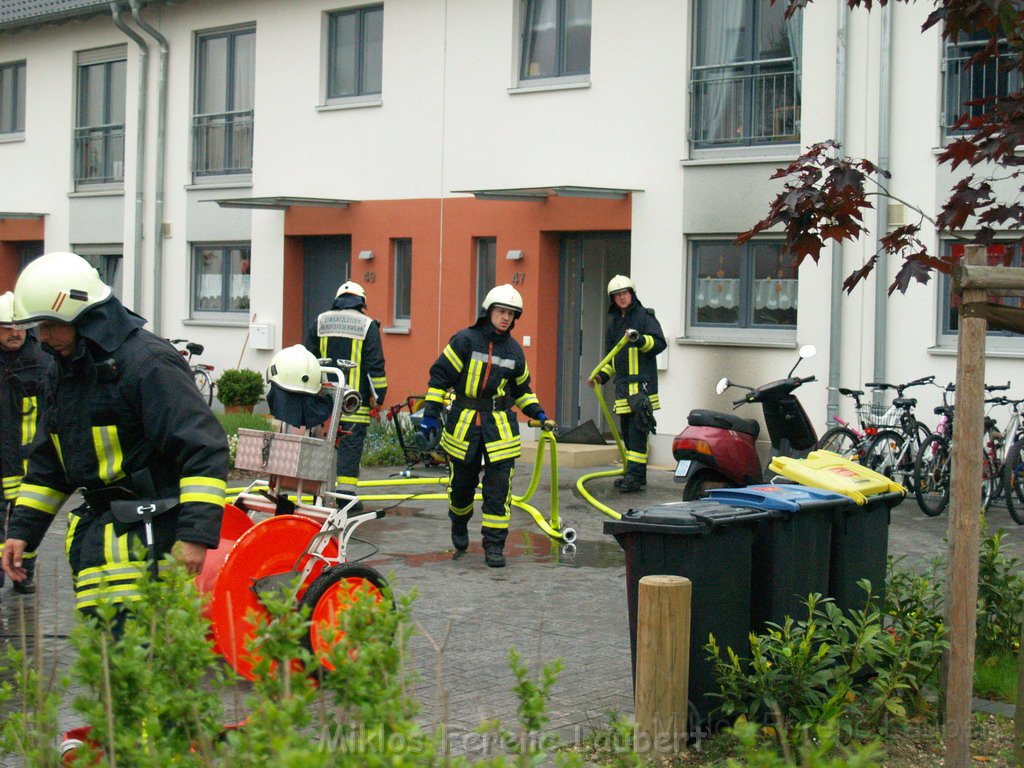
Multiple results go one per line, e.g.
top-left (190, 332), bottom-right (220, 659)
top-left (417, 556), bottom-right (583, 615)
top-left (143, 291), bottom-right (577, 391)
top-left (193, 28), bottom-right (256, 176)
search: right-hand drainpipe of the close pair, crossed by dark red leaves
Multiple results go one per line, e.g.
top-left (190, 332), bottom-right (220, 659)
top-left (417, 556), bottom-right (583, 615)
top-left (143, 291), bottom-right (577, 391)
top-left (873, 5), bottom-right (893, 401)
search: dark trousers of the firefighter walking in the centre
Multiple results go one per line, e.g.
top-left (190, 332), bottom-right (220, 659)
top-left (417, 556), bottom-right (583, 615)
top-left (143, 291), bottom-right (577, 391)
top-left (449, 445), bottom-right (515, 552)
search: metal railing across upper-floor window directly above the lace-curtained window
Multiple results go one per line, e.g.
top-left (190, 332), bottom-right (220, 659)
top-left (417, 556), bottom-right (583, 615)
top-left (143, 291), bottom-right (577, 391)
top-left (691, 57), bottom-right (800, 147)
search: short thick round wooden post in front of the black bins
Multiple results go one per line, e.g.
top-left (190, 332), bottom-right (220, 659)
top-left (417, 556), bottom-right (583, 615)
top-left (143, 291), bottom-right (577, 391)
top-left (633, 575), bottom-right (693, 758)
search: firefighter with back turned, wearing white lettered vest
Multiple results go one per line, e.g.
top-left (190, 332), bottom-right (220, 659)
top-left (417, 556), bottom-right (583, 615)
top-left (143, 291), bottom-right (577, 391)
top-left (306, 281), bottom-right (387, 512)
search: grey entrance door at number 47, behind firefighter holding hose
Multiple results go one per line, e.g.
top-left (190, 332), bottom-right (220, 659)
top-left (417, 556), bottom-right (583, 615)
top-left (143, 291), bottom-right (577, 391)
top-left (557, 232), bottom-right (630, 432)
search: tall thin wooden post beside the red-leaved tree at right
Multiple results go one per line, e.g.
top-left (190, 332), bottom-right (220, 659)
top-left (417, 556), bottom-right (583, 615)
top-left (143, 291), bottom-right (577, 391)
top-left (945, 246), bottom-right (988, 768)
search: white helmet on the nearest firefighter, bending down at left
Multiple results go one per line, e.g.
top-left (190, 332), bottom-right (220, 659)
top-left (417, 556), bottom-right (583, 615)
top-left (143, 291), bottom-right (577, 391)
top-left (14, 252), bottom-right (111, 323)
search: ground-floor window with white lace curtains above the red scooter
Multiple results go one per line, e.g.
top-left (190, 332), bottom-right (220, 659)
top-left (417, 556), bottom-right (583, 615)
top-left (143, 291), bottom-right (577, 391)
top-left (689, 240), bottom-right (799, 338)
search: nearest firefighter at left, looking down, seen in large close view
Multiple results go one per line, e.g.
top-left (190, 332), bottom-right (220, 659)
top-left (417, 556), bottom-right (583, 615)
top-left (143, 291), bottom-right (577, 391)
top-left (3, 253), bottom-right (227, 612)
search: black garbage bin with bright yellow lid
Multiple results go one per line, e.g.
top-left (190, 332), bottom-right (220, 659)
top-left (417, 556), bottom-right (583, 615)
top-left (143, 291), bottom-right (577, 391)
top-left (770, 451), bottom-right (906, 610)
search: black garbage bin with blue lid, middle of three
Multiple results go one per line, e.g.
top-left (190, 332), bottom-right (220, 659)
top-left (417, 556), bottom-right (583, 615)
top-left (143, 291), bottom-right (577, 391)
top-left (709, 484), bottom-right (855, 632)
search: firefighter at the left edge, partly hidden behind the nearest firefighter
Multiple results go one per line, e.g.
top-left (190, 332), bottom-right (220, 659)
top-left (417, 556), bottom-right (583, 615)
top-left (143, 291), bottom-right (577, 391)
top-left (0, 291), bottom-right (53, 595)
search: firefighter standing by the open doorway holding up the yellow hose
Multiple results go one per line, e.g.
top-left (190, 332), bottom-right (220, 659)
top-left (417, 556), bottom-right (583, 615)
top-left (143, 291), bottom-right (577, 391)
top-left (590, 274), bottom-right (668, 494)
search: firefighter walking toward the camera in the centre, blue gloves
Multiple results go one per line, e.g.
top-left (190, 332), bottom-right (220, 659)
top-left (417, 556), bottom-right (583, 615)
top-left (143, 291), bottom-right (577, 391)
top-left (420, 285), bottom-right (548, 568)
